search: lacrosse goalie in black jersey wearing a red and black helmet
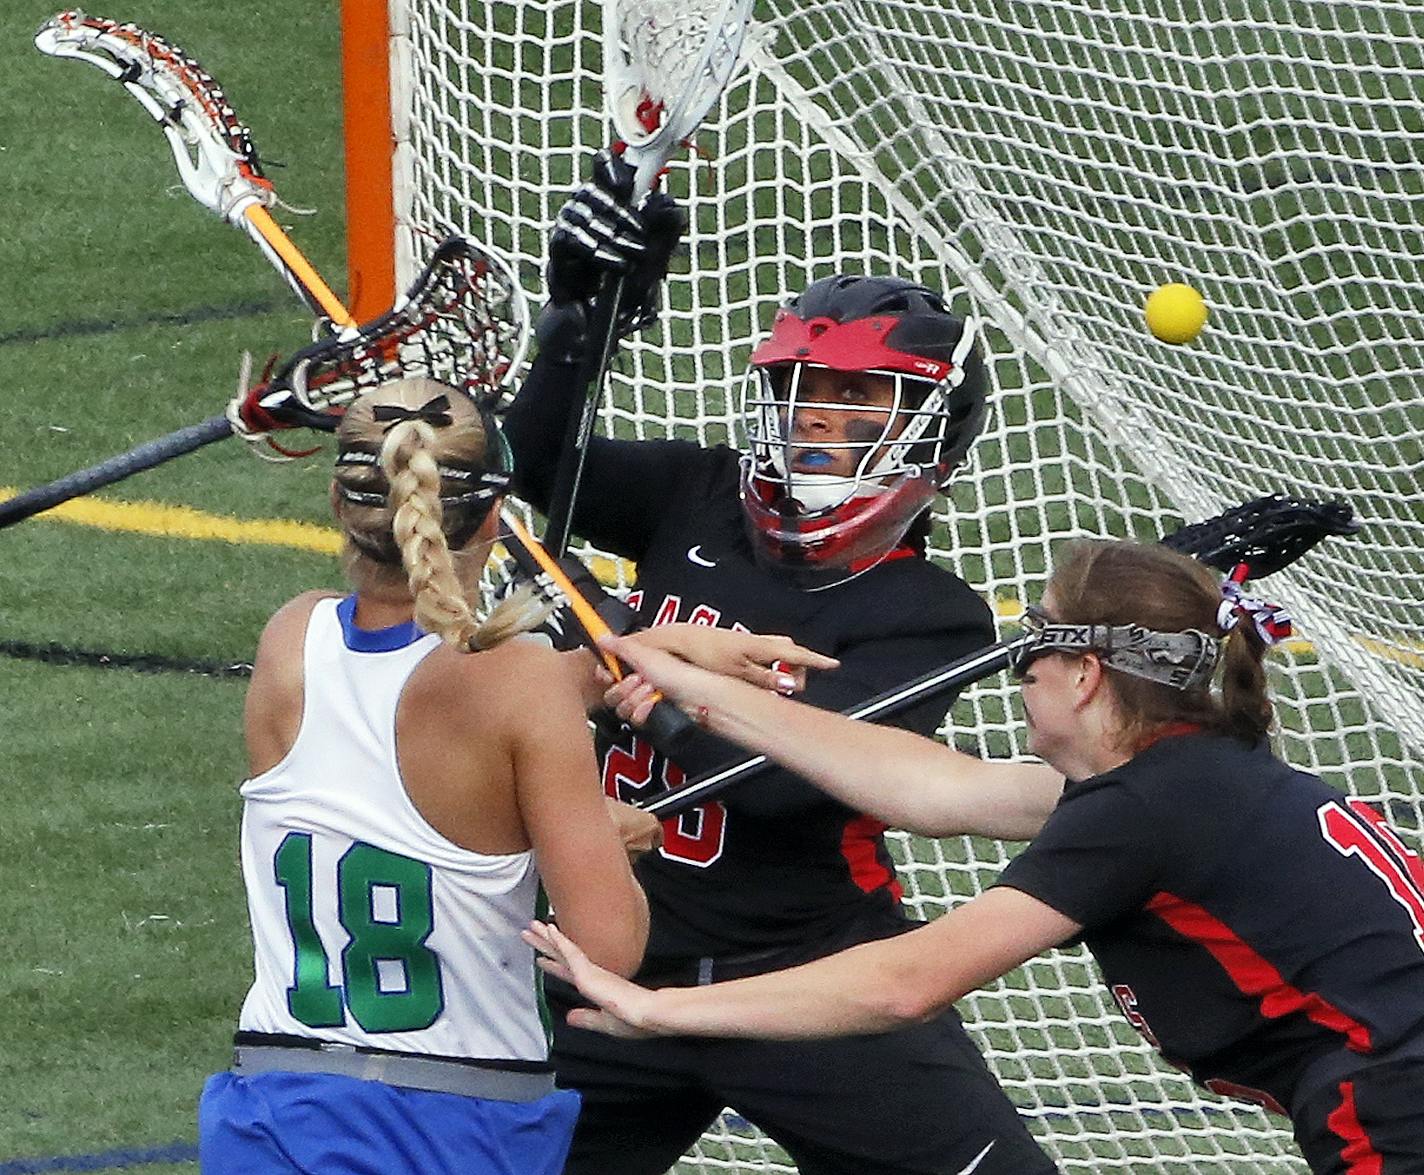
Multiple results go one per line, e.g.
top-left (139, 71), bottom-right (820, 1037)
top-left (506, 154), bottom-right (1054, 1175)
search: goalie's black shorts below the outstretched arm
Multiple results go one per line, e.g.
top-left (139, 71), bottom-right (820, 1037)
top-left (548, 919), bottom-right (1055, 1175)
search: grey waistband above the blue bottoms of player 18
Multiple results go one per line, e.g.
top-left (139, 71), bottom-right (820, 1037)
top-left (232, 1044), bottom-right (554, 1101)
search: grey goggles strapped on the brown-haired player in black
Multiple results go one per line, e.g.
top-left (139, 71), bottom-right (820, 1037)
top-left (1008, 605), bottom-right (1222, 689)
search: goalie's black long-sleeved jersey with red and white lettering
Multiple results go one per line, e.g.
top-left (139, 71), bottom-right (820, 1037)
top-left (506, 346), bottom-right (994, 974)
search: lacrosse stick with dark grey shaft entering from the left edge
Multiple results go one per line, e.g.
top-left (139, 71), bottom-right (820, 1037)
top-left (0, 236), bottom-right (528, 527)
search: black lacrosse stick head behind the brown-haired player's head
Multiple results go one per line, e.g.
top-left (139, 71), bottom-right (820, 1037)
top-left (1162, 494), bottom-right (1360, 580)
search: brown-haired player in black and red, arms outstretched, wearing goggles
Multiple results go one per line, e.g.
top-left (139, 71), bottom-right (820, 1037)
top-left (530, 541), bottom-right (1424, 1175)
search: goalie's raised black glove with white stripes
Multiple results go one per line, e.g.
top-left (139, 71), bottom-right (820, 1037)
top-left (548, 150), bottom-right (686, 336)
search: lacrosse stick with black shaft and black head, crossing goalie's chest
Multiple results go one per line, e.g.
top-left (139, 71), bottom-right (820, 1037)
top-left (642, 494), bottom-right (1360, 819)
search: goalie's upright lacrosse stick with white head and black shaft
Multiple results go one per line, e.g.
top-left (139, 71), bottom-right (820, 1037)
top-left (544, 0), bottom-right (752, 557)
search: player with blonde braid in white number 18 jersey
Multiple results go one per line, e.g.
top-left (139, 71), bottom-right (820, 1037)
top-left (199, 377), bottom-right (648, 1175)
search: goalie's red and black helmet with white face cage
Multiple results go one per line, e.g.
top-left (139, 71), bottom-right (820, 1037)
top-left (742, 276), bottom-right (987, 570)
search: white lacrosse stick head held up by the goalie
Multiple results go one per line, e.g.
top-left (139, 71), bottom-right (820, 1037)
top-left (604, 0), bottom-right (752, 195)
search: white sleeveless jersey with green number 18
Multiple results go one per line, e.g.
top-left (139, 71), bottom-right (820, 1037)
top-left (239, 597), bottom-right (548, 1061)
